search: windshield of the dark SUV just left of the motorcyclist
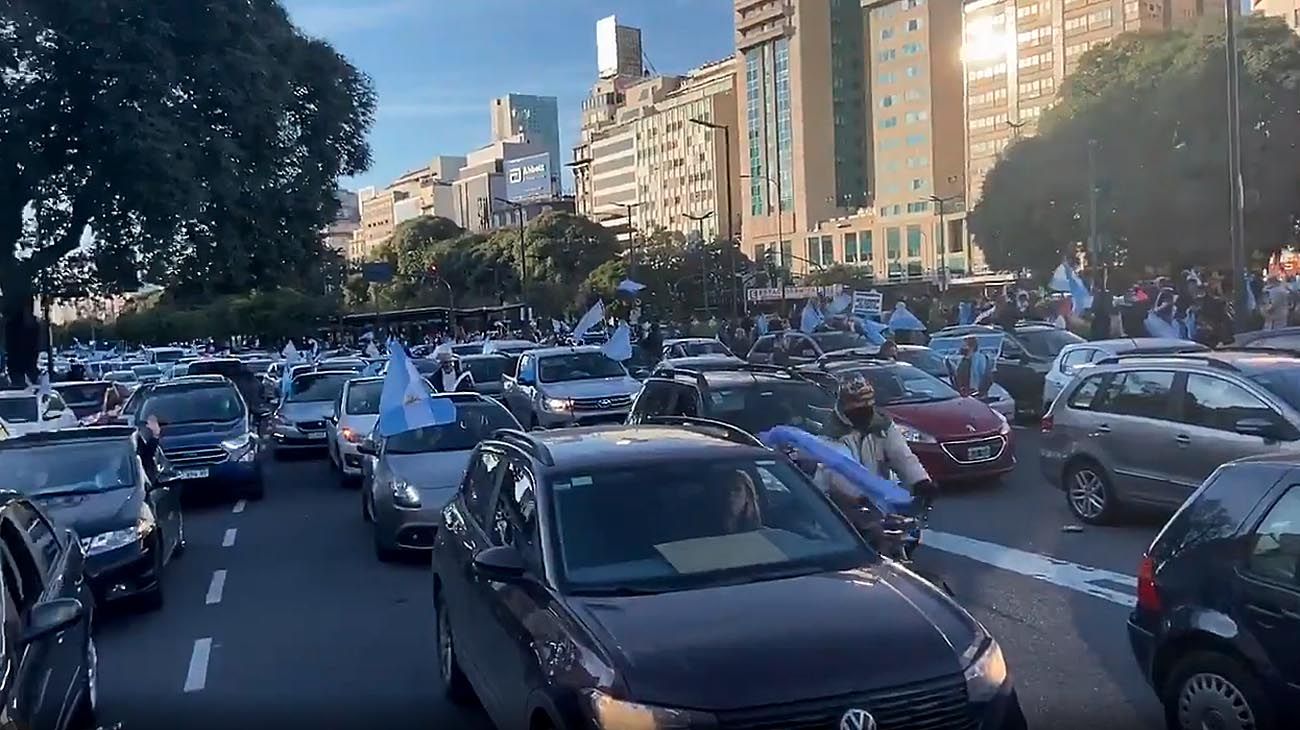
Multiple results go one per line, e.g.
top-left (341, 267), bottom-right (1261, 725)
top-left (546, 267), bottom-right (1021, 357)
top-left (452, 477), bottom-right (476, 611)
top-left (707, 381), bottom-right (835, 434)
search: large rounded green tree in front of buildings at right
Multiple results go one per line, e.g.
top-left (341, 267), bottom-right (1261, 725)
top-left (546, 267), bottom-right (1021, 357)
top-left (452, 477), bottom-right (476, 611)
top-left (970, 17), bottom-right (1300, 277)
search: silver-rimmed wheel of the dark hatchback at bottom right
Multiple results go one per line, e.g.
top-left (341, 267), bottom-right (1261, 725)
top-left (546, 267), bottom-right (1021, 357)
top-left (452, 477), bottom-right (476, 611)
top-left (1161, 652), bottom-right (1277, 730)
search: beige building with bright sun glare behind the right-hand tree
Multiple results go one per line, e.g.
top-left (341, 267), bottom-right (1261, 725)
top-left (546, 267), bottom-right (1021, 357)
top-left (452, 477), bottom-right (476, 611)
top-left (962, 0), bottom-right (1227, 204)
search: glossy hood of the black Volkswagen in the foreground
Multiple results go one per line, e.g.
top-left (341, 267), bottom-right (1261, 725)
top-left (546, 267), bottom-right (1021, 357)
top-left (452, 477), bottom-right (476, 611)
top-left (571, 564), bottom-right (980, 711)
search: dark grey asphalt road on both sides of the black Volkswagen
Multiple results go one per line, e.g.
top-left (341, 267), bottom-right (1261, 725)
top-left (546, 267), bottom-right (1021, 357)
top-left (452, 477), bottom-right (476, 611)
top-left (99, 431), bottom-right (1161, 730)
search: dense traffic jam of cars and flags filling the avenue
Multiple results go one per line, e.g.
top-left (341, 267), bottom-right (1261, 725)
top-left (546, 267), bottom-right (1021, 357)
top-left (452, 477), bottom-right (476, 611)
top-left (0, 321), bottom-right (1300, 730)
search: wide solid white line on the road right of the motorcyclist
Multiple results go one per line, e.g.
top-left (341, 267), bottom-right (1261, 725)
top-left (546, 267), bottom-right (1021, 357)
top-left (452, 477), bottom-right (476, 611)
top-left (920, 530), bottom-right (1138, 607)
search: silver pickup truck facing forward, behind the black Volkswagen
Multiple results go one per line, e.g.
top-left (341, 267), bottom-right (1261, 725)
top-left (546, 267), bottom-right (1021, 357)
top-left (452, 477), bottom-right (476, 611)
top-left (501, 346), bottom-right (641, 429)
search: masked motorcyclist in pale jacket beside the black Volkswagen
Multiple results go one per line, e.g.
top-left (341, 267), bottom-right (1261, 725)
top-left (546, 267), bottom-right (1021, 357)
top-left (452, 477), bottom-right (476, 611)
top-left (814, 375), bottom-right (939, 546)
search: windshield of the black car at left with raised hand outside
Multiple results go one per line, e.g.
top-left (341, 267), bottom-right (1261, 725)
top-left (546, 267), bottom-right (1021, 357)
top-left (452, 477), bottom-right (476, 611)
top-left (0, 438), bottom-right (135, 496)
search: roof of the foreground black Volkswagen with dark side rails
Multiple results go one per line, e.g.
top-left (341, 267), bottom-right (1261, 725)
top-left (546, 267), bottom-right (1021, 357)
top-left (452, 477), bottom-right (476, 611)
top-left (496, 423), bottom-right (772, 472)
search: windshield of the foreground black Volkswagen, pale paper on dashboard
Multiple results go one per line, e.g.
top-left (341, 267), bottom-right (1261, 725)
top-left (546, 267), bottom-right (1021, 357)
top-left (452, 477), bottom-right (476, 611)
top-left (551, 459), bottom-right (875, 594)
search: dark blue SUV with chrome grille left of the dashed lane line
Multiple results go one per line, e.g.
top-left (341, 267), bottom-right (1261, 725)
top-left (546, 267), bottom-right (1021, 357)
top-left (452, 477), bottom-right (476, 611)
top-left (137, 375), bottom-right (265, 500)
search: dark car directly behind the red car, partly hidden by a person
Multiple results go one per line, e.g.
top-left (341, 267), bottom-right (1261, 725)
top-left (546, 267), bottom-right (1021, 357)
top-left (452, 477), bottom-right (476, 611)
top-left (931, 321), bottom-right (1086, 416)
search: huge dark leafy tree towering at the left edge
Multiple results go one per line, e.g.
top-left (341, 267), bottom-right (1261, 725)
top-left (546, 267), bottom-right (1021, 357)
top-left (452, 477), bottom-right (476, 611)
top-left (0, 0), bottom-right (374, 381)
